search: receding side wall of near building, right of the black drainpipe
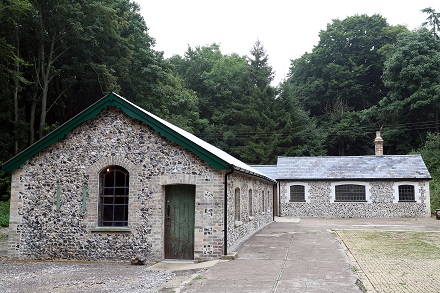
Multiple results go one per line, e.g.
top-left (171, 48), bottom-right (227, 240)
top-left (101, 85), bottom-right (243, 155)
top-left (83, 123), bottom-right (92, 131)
top-left (227, 173), bottom-right (273, 252)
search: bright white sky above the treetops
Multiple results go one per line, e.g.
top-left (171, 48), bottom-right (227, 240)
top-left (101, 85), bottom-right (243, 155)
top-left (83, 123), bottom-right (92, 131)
top-left (139, 0), bottom-right (440, 84)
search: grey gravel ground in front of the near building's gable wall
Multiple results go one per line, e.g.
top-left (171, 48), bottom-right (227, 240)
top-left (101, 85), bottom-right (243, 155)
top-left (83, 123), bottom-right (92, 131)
top-left (0, 228), bottom-right (194, 293)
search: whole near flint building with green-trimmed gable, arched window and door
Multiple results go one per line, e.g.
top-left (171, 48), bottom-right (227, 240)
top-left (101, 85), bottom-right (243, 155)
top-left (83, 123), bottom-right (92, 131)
top-left (2, 93), bottom-right (276, 261)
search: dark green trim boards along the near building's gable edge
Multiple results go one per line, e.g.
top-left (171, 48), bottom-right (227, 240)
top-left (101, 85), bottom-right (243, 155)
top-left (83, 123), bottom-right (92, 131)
top-left (2, 93), bottom-right (231, 172)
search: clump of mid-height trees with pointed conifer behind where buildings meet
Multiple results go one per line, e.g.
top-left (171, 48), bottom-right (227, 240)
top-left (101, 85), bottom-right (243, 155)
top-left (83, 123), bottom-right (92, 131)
top-left (170, 41), bottom-right (322, 164)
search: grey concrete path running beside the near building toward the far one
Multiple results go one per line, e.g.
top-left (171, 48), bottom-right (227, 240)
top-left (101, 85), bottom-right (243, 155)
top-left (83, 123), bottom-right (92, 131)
top-left (181, 219), bottom-right (361, 292)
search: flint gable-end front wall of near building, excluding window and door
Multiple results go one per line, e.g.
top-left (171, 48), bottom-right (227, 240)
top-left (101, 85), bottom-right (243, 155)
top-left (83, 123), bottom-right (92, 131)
top-left (8, 108), bottom-right (230, 260)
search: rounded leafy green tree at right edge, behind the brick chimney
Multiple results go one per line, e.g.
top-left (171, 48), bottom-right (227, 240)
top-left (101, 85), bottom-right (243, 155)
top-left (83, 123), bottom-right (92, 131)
top-left (372, 29), bottom-right (440, 153)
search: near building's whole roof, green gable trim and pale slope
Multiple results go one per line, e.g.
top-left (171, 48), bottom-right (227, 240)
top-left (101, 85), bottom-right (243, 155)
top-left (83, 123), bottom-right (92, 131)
top-left (2, 93), bottom-right (271, 180)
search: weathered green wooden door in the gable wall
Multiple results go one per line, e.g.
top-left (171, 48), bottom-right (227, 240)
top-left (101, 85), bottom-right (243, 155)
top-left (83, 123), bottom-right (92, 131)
top-left (165, 185), bottom-right (195, 259)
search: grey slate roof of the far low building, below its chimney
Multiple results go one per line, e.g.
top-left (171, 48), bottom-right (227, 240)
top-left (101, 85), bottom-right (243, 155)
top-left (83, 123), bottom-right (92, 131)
top-left (254, 155), bottom-right (431, 180)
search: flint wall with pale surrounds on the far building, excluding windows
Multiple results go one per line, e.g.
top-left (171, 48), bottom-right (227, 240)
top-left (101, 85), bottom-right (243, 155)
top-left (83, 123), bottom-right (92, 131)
top-left (279, 180), bottom-right (430, 218)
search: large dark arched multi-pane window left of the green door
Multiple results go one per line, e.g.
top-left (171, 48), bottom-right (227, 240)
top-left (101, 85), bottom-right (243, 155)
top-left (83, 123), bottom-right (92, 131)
top-left (98, 166), bottom-right (129, 226)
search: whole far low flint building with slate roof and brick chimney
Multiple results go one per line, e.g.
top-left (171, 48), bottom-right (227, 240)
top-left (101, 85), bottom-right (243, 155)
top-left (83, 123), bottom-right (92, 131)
top-left (253, 153), bottom-right (431, 218)
